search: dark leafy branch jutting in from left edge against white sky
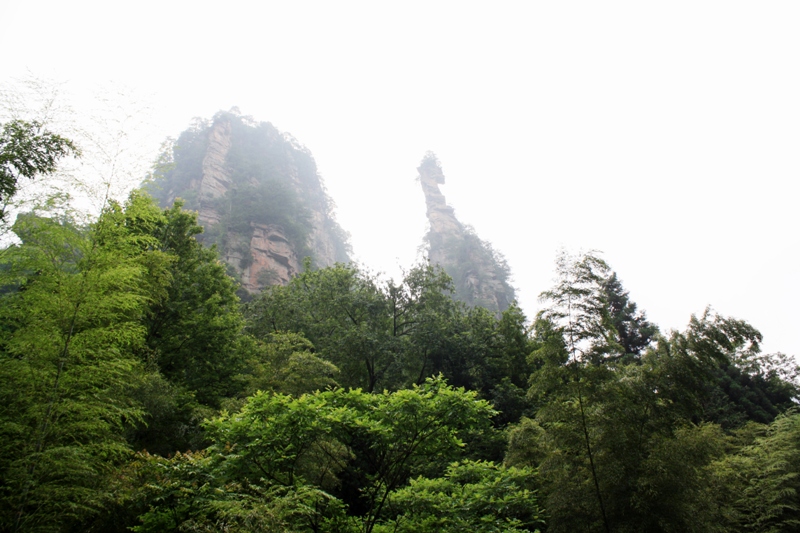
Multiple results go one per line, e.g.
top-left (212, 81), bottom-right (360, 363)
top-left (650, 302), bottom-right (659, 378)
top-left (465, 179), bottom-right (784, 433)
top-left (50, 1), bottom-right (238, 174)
top-left (0, 120), bottom-right (79, 222)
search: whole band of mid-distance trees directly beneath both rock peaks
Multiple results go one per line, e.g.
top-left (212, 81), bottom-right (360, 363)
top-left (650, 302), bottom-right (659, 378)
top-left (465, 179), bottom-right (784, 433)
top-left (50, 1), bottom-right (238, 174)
top-left (247, 265), bottom-right (530, 408)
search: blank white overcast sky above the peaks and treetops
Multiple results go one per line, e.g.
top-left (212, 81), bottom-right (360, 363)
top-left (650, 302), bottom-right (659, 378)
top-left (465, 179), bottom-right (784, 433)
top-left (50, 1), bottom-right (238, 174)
top-left (0, 0), bottom-right (800, 356)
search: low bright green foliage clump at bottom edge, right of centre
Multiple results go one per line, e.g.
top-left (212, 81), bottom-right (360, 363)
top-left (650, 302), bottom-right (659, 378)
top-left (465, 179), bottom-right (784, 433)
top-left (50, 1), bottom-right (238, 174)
top-left (375, 461), bottom-right (543, 533)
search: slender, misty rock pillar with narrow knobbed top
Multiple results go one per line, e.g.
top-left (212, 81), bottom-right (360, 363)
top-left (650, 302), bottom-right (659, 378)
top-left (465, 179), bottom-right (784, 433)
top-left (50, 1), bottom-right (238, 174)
top-left (417, 152), bottom-right (516, 312)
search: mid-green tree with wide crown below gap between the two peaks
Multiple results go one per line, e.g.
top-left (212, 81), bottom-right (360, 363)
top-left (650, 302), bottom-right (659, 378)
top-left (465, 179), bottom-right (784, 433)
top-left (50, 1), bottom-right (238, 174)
top-left (248, 264), bottom-right (456, 392)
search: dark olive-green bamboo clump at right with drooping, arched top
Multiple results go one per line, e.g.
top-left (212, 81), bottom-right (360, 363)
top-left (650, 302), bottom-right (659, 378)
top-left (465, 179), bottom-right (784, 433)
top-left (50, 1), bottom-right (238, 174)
top-left (507, 302), bottom-right (772, 531)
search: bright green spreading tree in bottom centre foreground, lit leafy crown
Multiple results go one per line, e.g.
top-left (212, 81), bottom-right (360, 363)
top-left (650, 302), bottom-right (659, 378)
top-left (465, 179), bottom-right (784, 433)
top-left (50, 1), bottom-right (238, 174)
top-left (136, 379), bottom-right (492, 532)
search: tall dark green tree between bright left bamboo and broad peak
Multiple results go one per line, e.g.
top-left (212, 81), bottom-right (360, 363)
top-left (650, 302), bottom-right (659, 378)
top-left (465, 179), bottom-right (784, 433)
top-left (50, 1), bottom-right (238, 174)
top-left (106, 190), bottom-right (250, 455)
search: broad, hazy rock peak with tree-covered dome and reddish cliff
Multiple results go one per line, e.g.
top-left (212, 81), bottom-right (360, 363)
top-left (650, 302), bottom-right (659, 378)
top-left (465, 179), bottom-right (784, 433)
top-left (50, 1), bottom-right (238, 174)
top-left (151, 113), bottom-right (349, 293)
